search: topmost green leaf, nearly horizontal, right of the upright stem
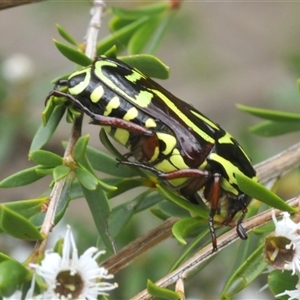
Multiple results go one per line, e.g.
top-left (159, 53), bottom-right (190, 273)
top-left (110, 2), bottom-right (171, 20)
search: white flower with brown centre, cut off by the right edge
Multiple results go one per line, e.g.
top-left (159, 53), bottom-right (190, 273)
top-left (265, 211), bottom-right (300, 275)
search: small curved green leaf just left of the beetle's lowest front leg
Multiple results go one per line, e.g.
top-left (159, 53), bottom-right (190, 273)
top-left (172, 218), bottom-right (207, 245)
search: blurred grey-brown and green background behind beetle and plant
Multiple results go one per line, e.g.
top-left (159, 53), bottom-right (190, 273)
top-left (0, 1), bottom-right (300, 299)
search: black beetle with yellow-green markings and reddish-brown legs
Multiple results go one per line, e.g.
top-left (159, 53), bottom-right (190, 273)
top-left (47, 56), bottom-right (257, 250)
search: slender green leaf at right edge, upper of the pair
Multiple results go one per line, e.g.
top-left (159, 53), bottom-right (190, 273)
top-left (236, 104), bottom-right (300, 122)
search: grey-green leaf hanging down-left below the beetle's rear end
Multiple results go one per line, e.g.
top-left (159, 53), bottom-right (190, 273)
top-left (29, 105), bottom-right (66, 152)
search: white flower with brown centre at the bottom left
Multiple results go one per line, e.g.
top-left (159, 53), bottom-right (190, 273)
top-left (30, 227), bottom-right (117, 300)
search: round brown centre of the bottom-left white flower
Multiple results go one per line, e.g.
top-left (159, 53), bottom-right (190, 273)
top-left (54, 270), bottom-right (84, 299)
